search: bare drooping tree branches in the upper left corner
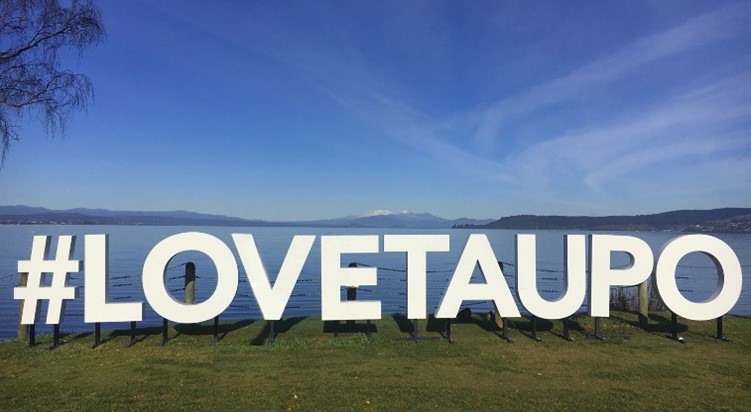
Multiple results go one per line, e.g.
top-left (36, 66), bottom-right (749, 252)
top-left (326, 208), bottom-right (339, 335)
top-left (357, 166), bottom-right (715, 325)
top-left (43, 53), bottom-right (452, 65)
top-left (0, 0), bottom-right (106, 167)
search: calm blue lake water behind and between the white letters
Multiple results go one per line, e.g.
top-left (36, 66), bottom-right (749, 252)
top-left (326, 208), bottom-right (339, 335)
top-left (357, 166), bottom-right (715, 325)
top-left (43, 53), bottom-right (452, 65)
top-left (0, 225), bottom-right (751, 339)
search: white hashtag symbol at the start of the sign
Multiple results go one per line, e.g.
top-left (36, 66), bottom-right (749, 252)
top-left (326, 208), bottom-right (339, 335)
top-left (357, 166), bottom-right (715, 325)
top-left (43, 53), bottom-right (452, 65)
top-left (13, 236), bottom-right (81, 325)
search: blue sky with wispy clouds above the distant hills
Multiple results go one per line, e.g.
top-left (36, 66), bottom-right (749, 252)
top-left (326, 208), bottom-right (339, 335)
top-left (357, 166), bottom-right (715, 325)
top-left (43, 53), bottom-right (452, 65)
top-left (0, 0), bottom-right (751, 220)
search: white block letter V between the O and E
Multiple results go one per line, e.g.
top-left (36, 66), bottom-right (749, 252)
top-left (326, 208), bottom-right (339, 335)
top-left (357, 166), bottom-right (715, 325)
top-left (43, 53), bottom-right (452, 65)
top-left (232, 234), bottom-right (316, 320)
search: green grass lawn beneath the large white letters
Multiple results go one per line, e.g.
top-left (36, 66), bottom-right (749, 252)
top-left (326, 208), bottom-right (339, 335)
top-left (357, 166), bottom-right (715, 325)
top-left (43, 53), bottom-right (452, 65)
top-left (0, 312), bottom-right (751, 411)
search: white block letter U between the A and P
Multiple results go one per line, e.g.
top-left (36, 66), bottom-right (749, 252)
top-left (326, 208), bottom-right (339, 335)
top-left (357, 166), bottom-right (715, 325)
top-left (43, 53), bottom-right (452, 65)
top-left (516, 235), bottom-right (587, 319)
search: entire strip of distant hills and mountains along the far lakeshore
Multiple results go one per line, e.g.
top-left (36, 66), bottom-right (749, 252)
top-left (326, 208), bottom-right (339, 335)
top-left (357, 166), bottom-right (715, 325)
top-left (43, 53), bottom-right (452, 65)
top-left (10, 206), bottom-right (751, 233)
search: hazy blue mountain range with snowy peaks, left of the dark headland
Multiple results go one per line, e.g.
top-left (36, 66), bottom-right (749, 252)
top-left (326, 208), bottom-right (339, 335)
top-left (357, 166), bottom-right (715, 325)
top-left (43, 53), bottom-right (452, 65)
top-left (0, 206), bottom-right (493, 229)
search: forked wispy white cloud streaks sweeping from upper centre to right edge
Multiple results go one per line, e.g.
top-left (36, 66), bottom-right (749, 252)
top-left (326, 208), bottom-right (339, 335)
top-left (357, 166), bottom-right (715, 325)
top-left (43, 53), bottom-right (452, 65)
top-left (151, 3), bottom-right (751, 212)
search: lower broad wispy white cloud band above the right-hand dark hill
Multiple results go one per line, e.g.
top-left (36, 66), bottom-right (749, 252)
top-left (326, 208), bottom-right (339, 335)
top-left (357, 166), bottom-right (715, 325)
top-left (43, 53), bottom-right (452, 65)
top-left (510, 72), bottom-right (751, 189)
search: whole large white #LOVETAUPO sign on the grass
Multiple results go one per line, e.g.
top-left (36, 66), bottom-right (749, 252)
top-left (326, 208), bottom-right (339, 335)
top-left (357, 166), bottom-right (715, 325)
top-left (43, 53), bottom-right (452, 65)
top-left (14, 232), bottom-right (742, 324)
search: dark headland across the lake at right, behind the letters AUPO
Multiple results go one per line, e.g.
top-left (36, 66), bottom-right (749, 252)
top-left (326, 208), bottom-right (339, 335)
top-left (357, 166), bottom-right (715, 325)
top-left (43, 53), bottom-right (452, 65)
top-left (457, 208), bottom-right (751, 233)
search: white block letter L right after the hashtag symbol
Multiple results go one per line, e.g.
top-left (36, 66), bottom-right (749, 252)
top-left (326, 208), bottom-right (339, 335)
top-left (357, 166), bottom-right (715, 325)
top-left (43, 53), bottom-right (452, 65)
top-left (83, 235), bottom-right (143, 323)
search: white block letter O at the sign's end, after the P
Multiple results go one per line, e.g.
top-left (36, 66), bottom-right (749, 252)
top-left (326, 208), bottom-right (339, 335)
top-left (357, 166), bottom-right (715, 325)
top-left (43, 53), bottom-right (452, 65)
top-left (655, 235), bottom-right (743, 320)
